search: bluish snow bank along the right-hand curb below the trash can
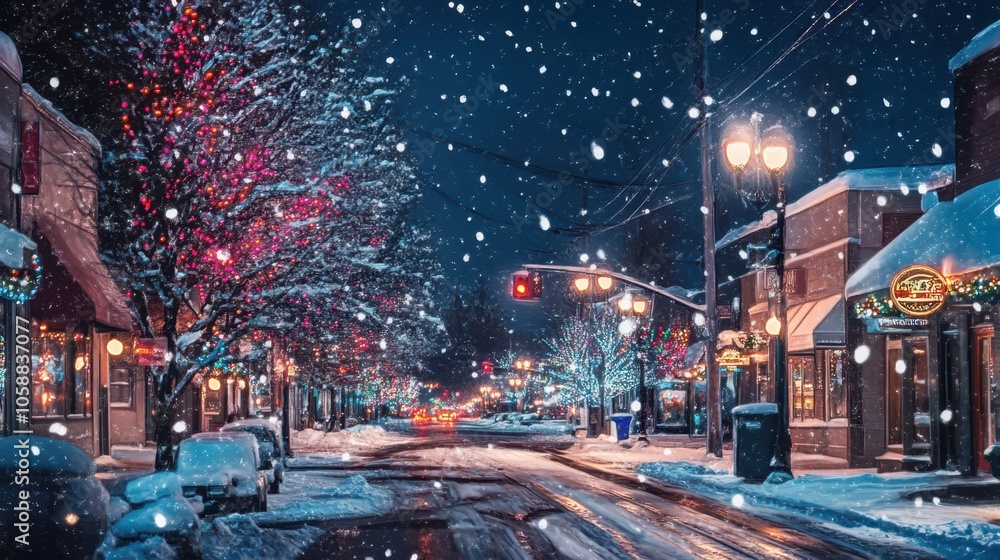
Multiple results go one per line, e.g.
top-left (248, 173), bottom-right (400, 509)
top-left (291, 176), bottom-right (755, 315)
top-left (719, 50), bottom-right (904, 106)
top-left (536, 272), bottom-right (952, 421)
top-left (637, 462), bottom-right (1000, 558)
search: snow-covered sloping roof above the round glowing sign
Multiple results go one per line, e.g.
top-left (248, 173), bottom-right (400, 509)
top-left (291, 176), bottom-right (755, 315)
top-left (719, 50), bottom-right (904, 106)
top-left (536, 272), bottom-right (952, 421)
top-left (845, 180), bottom-right (1000, 297)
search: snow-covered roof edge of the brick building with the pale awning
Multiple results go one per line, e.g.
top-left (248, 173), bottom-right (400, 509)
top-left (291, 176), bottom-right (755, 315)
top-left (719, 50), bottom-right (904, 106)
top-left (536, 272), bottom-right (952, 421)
top-left (715, 164), bottom-right (955, 249)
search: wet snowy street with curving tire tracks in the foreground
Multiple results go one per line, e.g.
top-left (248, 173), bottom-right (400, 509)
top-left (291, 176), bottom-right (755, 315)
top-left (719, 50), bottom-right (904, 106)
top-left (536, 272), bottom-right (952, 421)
top-left (197, 426), bottom-right (935, 559)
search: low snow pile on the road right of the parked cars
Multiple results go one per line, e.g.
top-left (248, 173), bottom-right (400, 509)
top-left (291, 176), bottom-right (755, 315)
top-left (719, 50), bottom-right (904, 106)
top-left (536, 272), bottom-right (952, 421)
top-left (254, 472), bottom-right (393, 524)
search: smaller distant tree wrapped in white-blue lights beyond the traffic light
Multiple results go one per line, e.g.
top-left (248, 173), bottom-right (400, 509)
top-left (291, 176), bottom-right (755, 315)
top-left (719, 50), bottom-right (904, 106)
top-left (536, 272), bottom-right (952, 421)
top-left (546, 309), bottom-right (639, 406)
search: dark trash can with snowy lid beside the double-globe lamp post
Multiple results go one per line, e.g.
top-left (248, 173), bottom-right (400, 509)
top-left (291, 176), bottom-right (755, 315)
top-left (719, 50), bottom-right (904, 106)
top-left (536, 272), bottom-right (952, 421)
top-left (733, 403), bottom-right (778, 481)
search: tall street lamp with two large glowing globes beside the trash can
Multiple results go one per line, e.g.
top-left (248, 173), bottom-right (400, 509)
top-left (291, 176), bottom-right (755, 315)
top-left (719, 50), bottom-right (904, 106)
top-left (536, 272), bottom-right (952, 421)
top-left (723, 119), bottom-right (792, 475)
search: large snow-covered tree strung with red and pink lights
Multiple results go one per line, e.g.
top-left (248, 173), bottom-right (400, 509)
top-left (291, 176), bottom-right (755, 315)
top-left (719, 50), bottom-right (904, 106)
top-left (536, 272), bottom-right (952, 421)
top-left (105, 0), bottom-right (442, 468)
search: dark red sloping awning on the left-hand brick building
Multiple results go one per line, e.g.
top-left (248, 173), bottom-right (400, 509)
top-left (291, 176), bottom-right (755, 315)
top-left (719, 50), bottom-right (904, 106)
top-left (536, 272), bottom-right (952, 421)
top-left (35, 212), bottom-right (132, 331)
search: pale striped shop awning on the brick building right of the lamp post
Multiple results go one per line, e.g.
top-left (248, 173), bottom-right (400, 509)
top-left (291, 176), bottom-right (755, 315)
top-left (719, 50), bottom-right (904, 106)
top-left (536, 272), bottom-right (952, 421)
top-left (787, 295), bottom-right (847, 352)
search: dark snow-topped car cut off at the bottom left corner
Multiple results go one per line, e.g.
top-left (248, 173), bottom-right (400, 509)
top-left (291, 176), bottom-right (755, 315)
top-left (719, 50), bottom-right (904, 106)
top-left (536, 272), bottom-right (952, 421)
top-left (0, 436), bottom-right (120, 559)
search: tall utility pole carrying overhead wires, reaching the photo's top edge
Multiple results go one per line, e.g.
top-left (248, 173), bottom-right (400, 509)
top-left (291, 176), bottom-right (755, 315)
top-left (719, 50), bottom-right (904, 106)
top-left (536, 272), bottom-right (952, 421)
top-left (694, 0), bottom-right (722, 457)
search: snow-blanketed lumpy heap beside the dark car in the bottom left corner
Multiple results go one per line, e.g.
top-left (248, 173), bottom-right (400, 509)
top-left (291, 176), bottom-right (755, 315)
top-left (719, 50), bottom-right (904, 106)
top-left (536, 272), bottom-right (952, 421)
top-left (95, 472), bottom-right (202, 560)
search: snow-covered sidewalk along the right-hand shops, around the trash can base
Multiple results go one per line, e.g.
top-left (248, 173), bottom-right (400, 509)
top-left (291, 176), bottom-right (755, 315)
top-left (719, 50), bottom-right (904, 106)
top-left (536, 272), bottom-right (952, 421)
top-left (567, 437), bottom-right (1000, 558)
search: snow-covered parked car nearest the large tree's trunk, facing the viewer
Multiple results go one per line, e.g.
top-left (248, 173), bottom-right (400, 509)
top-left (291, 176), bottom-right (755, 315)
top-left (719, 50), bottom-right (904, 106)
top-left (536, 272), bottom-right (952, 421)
top-left (174, 432), bottom-right (268, 513)
